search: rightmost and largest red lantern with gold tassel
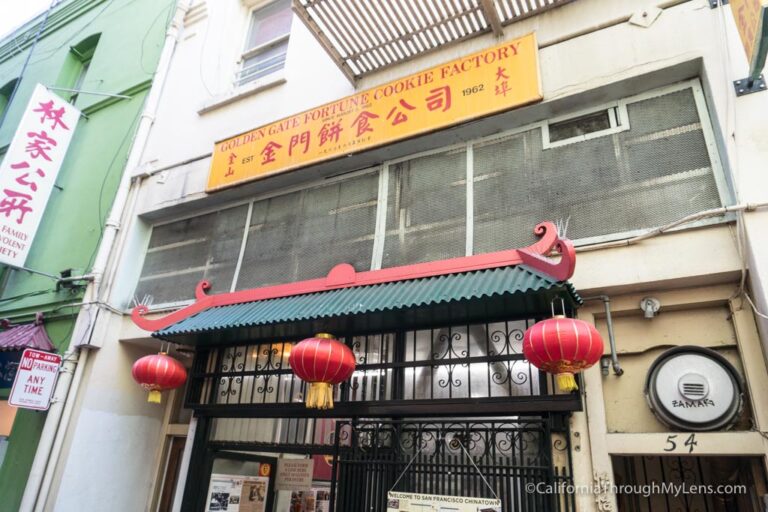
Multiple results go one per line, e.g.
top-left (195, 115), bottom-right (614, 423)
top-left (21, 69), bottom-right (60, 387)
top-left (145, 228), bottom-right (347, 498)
top-left (523, 316), bottom-right (603, 391)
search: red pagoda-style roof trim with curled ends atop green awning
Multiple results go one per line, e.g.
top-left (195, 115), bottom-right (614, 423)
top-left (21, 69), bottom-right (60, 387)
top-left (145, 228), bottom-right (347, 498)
top-left (131, 222), bottom-right (576, 331)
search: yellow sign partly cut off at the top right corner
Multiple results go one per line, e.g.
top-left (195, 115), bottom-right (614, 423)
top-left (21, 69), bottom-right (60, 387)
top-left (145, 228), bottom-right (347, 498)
top-left (731, 0), bottom-right (768, 80)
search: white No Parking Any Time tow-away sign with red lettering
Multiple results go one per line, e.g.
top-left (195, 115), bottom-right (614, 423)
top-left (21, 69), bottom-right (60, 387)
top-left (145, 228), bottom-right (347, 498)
top-left (8, 348), bottom-right (61, 411)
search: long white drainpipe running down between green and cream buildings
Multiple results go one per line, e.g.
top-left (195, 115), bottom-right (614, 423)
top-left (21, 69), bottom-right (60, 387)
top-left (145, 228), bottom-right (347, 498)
top-left (19, 0), bottom-right (190, 512)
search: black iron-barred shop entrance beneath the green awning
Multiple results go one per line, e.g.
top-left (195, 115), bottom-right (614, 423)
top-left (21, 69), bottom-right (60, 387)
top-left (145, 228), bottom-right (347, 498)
top-left (184, 319), bottom-right (581, 512)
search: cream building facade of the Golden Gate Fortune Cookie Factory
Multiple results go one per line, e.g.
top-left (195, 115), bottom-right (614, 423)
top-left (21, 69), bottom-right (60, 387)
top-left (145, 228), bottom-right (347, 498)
top-left (25, 0), bottom-right (768, 511)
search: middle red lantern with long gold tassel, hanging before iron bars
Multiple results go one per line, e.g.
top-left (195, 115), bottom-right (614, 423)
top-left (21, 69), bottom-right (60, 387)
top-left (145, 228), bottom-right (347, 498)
top-left (288, 333), bottom-right (355, 409)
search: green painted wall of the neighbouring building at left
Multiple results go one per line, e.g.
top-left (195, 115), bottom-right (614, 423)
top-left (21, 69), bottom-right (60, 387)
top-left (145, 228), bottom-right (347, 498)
top-left (0, 0), bottom-right (176, 506)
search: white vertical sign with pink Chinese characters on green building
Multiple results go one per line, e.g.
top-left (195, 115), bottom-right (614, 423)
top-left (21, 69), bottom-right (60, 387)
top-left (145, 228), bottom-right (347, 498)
top-left (0, 84), bottom-right (80, 267)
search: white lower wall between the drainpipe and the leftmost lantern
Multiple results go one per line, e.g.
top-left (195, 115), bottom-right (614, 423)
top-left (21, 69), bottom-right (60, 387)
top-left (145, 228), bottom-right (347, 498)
top-left (46, 317), bottom-right (167, 512)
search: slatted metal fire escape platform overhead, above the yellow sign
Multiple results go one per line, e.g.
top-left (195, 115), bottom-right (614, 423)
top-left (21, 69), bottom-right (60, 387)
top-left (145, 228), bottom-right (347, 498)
top-left (293, 0), bottom-right (573, 82)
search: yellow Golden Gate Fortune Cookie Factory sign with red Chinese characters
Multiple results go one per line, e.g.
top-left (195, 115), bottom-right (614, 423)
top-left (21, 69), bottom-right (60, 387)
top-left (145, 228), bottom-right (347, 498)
top-left (207, 34), bottom-right (542, 191)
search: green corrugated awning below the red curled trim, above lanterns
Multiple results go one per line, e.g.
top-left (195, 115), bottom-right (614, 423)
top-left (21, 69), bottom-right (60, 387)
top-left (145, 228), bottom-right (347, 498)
top-left (153, 265), bottom-right (581, 345)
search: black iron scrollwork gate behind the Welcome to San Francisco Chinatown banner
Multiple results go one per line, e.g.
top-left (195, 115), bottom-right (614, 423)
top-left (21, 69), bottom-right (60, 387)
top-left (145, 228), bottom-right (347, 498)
top-left (331, 416), bottom-right (574, 512)
